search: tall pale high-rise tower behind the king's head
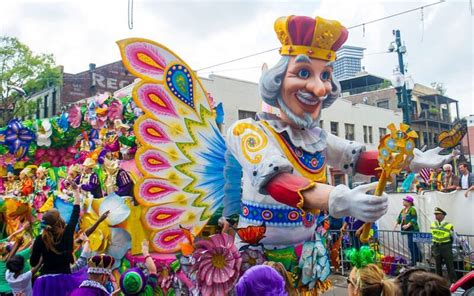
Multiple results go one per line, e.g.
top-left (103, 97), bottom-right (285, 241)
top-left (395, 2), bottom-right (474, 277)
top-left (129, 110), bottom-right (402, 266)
top-left (334, 45), bottom-right (365, 80)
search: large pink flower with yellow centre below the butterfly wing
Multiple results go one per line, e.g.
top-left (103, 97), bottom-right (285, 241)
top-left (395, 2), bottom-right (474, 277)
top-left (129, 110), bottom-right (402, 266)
top-left (193, 233), bottom-right (242, 296)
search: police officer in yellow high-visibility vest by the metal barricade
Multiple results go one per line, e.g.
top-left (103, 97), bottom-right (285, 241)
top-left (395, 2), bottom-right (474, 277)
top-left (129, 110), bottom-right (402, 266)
top-left (431, 207), bottom-right (456, 283)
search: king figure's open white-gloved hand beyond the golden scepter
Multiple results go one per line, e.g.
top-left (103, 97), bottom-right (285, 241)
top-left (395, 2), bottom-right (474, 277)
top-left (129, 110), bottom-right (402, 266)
top-left (410, 147), bottom-right (457, 173)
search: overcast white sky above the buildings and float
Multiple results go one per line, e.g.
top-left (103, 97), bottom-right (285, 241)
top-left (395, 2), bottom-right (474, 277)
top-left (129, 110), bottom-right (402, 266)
top-left (0, 0), bottom-right (474, 115)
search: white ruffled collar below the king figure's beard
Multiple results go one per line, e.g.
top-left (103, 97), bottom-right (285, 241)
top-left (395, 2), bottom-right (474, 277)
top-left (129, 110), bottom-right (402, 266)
top-left (257, 112), bottom-right (327, 153)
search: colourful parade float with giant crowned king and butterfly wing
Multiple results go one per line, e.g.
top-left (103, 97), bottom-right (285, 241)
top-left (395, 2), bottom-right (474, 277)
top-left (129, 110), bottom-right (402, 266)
top-left (0, 16), bottom-right (462, 295)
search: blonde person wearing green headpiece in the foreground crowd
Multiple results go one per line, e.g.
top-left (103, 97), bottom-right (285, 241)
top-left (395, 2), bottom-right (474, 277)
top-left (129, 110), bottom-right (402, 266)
top-left (347, 246), bottom-right (396, 296)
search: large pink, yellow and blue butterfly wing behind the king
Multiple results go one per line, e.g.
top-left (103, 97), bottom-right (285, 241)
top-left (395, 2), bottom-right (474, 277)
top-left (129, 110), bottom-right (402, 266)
top-left (117, 38), bottom-right (231, 253)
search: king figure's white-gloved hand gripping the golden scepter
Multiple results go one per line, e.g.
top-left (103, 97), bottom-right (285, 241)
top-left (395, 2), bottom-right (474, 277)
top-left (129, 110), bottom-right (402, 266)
top-left (329, 182), bottom-right (388, 222)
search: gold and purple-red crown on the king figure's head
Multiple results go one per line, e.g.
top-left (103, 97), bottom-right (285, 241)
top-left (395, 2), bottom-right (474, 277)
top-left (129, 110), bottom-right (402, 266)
top-left (275, 15), bottom-right (347, 61)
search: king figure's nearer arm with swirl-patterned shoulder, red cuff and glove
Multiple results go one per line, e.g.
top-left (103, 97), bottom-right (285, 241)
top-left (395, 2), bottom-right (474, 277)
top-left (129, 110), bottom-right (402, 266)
top-left (227, 119), bottom-right (388, 222)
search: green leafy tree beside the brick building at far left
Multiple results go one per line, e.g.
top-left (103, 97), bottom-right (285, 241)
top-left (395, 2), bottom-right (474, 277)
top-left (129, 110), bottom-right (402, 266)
top-left (0, 36), bottom-right (61, 125)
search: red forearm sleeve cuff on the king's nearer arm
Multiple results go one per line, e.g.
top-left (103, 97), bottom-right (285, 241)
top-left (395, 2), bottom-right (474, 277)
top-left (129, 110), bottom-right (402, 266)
top-left (265, 173), bottom-right (315, 210)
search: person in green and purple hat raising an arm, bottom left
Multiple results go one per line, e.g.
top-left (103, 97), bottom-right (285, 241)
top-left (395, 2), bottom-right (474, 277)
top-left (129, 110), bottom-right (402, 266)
top-left (120, 240), bottom-right (158, 296)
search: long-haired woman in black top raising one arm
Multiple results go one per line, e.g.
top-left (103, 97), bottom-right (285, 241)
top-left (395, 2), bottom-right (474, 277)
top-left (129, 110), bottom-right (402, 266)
top-left (30, 184), bottom-right (80, 274)
